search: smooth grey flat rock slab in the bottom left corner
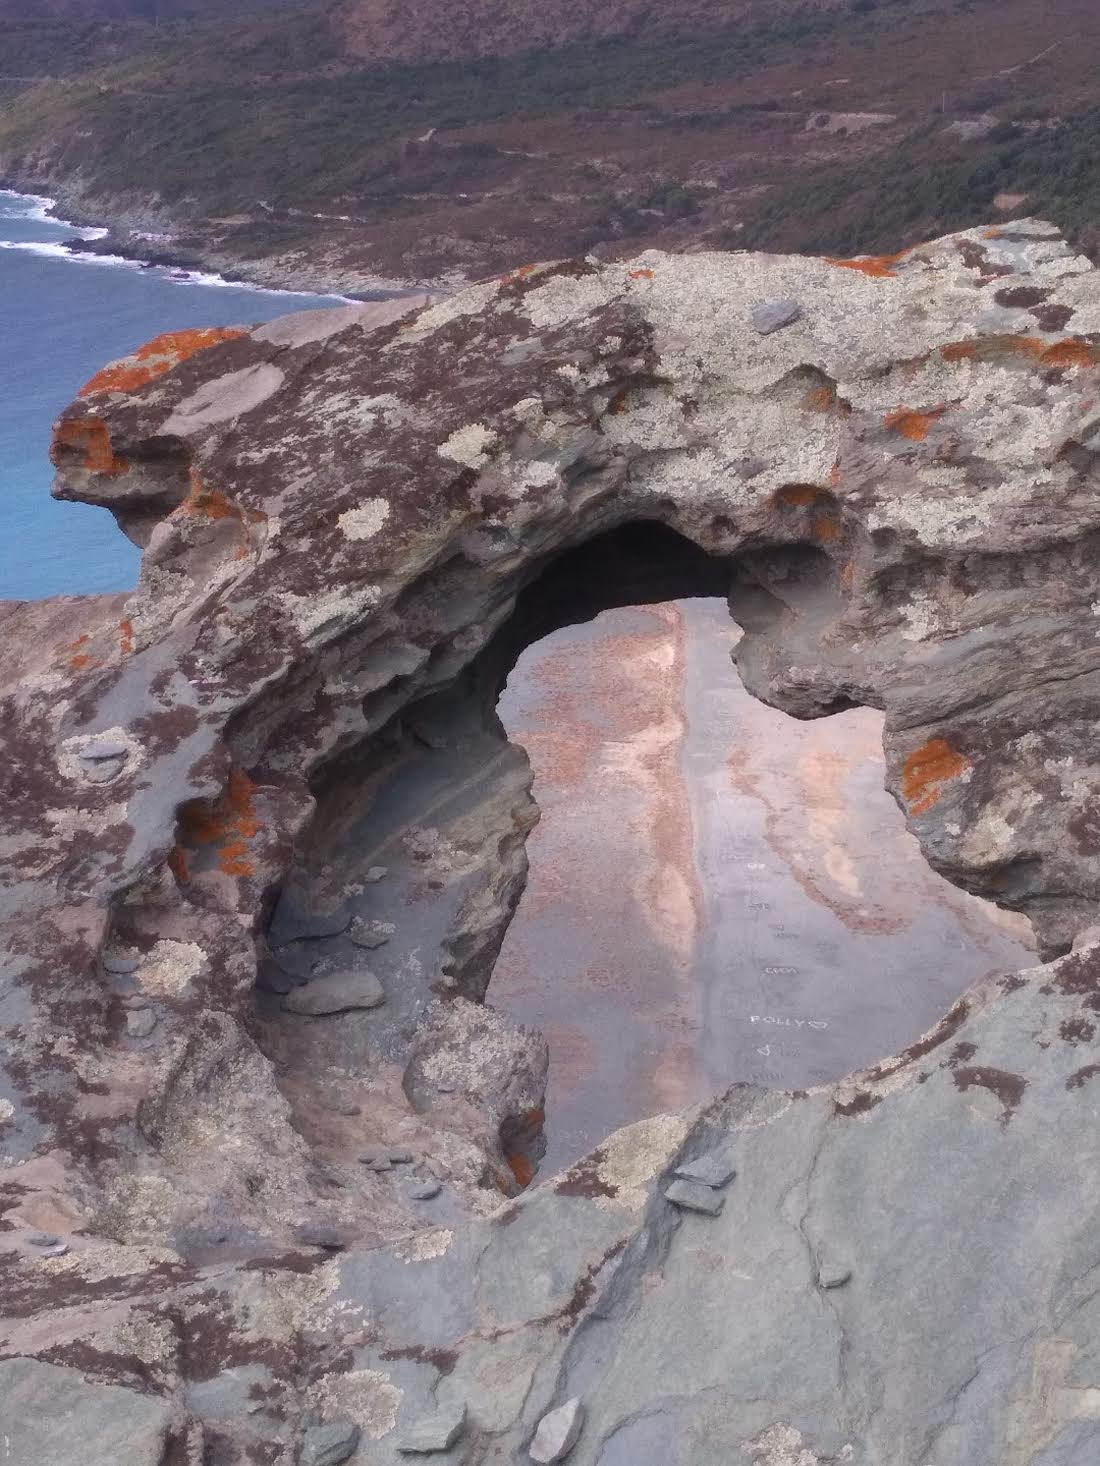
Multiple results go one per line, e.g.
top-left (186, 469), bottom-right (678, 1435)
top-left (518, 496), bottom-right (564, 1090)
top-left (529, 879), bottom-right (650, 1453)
top-left (0, 1359), bottom-right (172, 1466)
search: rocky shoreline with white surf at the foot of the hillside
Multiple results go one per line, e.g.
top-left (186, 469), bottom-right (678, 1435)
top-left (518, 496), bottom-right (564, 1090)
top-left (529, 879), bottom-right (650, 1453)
top-left (0, 174), bottom-right (457, 303)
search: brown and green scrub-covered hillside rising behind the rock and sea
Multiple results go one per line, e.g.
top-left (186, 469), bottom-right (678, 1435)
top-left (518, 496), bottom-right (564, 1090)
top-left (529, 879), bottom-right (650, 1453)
top-left (0, 0), bottom-right (1100, 289)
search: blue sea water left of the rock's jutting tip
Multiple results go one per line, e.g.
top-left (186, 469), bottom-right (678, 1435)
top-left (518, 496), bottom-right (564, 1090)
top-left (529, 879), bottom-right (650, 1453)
top-left (0, 192), bottom-right (336, 598)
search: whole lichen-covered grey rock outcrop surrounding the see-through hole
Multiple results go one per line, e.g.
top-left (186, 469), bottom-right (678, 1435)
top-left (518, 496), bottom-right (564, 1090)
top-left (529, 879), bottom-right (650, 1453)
top-left (0, 221), bottom-right (1100, 1466)
